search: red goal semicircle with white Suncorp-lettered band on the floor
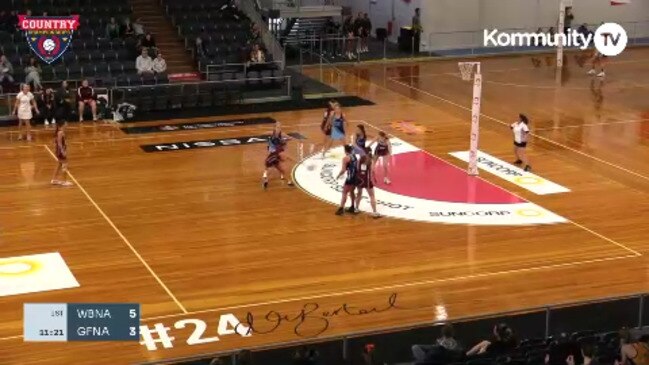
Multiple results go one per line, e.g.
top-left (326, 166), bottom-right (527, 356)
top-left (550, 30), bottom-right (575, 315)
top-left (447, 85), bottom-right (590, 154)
top-left (293, 138), bottom-right (566, 225)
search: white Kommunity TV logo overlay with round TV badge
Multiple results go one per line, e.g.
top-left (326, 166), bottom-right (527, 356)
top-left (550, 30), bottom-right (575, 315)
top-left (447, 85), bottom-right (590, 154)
top-left (483, 23), bottom-right (629, 56)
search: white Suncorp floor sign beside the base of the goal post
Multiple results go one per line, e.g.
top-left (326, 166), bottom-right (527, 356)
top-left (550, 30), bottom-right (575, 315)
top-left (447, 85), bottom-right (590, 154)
top-left (450, 151), bottom-right (570, 195)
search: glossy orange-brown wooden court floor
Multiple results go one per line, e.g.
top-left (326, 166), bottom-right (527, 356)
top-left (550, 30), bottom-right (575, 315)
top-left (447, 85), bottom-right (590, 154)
top-left (0, 49), bottom-right (649, 364)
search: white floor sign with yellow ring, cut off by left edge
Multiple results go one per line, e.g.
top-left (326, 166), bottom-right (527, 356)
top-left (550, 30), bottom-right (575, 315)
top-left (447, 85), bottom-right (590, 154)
top-left (0, 252), bottom-right (79, 297)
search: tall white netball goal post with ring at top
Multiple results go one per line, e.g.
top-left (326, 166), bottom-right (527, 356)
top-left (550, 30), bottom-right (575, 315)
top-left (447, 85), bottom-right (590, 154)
top-left (458, 62), bottom-right (482, 176)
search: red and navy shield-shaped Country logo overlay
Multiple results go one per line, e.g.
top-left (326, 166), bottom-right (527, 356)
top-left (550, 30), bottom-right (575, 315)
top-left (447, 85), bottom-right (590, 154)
top-left (18, 15), bottom-right (79, 64)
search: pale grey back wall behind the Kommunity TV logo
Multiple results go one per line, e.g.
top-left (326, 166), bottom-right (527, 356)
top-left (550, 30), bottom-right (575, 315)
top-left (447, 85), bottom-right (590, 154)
top-left (343, 0), bottom-right (649, 49)
